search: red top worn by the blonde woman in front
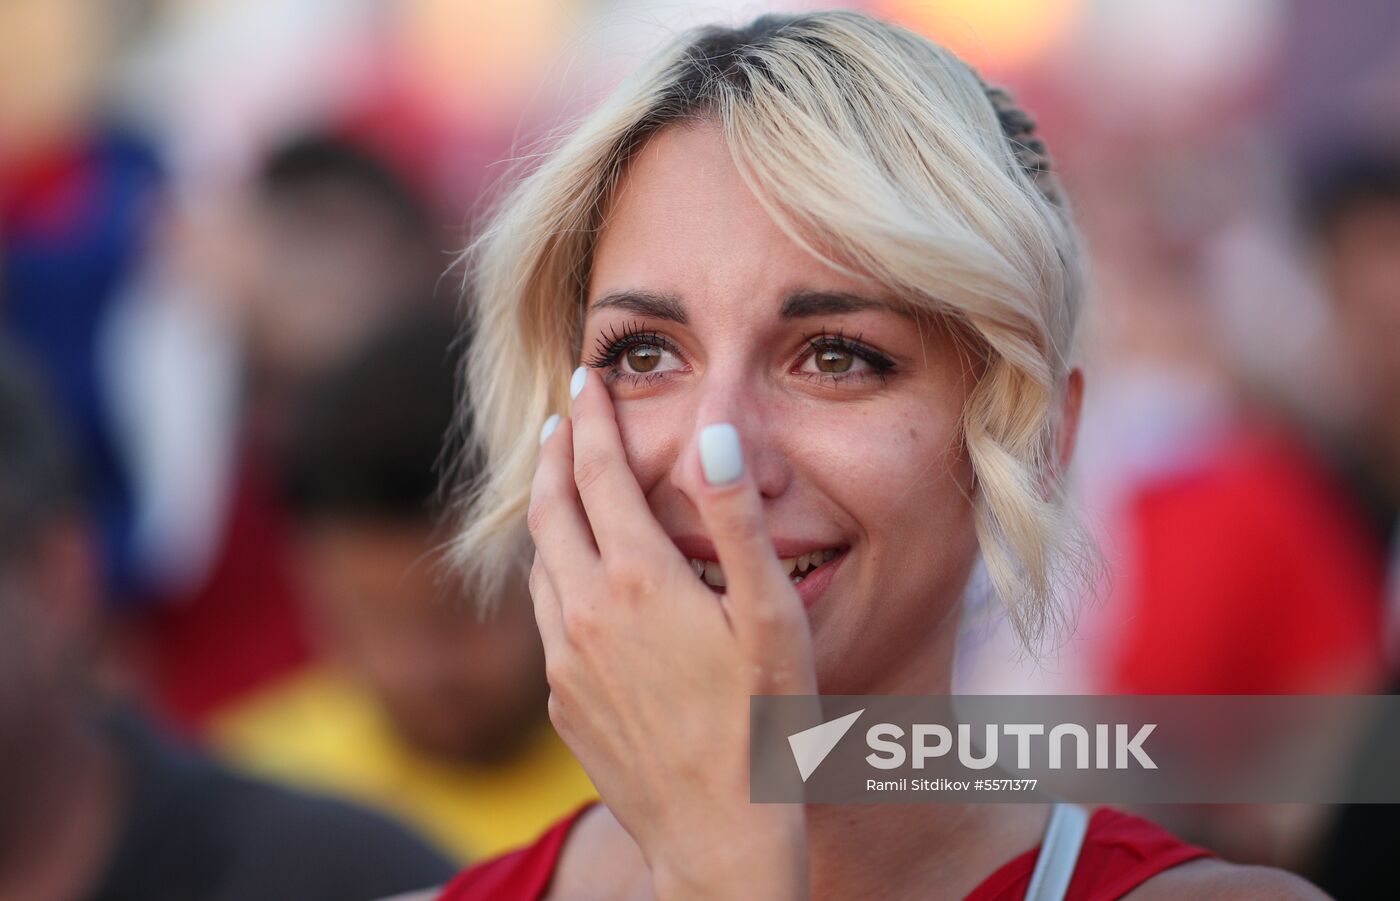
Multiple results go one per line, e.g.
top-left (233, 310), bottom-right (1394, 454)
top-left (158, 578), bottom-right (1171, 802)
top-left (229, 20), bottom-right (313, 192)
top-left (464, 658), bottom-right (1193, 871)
top-left (438, 802), bottom-right (1211, 901)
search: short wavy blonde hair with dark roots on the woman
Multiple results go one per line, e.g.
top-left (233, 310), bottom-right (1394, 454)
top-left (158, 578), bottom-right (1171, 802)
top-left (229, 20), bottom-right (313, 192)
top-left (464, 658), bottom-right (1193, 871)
top-left (454, 13), bottom-right (1082, 646)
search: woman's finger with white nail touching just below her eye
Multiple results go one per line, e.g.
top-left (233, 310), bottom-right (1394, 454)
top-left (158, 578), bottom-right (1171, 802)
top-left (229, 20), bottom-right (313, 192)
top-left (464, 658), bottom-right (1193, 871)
top-left (570, 367), bottom-right (679, 560)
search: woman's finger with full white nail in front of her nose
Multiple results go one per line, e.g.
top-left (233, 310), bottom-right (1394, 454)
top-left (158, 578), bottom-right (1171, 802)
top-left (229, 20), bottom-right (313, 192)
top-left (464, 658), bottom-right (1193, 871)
top-left (696, 423), bottom-right (805, 637)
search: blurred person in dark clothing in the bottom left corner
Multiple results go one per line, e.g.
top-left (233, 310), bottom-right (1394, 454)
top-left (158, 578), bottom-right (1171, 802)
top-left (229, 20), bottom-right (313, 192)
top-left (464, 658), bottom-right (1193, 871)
top-left (0, 347), bottom-right (451, 901)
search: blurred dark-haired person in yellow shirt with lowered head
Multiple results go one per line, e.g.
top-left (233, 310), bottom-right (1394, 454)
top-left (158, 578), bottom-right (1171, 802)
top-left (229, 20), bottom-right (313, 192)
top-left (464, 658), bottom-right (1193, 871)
top-left (211, 313), bottom-right (594, 859)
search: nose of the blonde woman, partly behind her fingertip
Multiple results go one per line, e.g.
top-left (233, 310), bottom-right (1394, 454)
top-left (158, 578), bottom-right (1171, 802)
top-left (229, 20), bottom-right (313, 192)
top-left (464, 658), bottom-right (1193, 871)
top-left (669, 369), bottom-right (792, 502)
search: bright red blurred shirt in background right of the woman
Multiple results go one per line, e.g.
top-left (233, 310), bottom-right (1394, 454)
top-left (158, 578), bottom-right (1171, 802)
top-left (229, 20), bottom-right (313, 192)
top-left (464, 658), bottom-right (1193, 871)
top-left (1106, 431), bottom-right (1383, 694)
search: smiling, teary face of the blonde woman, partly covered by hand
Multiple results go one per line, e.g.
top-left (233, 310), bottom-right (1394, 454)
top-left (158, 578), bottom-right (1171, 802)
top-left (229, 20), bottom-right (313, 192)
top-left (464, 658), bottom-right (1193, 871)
top-left (582, 125), bottom-right (976, 693)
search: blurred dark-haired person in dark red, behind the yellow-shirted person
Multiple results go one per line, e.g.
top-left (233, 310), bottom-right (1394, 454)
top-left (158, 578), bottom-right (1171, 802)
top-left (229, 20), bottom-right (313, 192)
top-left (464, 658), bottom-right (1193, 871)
top-left (128, 133), bottom-right (441, 735)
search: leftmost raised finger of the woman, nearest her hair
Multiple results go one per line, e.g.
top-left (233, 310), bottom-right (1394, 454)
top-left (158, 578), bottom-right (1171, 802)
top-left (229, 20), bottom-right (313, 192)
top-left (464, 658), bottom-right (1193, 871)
top-left (525, 417), bottom-right (599, 589)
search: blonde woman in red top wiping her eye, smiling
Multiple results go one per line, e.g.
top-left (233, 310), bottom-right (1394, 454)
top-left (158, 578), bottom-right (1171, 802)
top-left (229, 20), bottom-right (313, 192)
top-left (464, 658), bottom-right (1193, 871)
top-left (428, 13), bottom-right (1317, 900)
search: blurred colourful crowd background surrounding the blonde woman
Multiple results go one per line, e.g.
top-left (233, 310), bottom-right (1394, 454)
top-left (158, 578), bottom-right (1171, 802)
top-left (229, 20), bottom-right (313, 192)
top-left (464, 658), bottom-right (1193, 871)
top-left (0, 0), bottom-right (1400, 898)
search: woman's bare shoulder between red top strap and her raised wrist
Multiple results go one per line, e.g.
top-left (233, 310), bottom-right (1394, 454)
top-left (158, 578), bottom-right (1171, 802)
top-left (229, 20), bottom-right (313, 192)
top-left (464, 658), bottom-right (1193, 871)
top-left (547, 804), bottom-right (651, 901)
